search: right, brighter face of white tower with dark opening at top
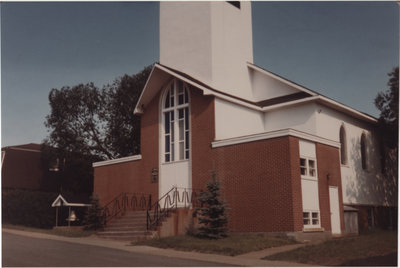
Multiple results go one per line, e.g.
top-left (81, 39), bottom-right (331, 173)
top-left (211, 1), bottom-right (253, 99)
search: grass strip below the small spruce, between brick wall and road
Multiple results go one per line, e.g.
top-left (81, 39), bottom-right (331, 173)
top-left (132, 234), bottom-right (295, 256)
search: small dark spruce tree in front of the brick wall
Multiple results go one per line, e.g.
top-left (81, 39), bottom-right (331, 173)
top-left (197, 171), bottom-right (228, 239)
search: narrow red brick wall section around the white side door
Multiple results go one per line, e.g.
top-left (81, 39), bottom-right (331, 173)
top-left (316, 143), bottom-right (345, 232)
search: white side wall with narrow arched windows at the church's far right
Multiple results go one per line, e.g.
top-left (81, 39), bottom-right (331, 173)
top-left (316, 105), bottom-right (397, 205)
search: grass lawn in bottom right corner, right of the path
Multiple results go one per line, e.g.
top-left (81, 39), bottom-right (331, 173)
top-left (264, 230), bottom-right (397, 266)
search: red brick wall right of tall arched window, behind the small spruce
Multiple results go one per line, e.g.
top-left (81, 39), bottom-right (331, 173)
top-left (191, 87), bottom-right (303, 232)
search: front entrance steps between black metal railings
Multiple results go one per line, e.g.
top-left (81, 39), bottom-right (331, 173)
top-left (97, 211), bottom-right (155, 241)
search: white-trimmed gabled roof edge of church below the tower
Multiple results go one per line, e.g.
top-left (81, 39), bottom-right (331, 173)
top-left (135, 63), bottom-right (377, 123)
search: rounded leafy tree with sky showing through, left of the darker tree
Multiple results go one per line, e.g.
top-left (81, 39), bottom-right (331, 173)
top-left (45, 83), bottom-right (113, 158)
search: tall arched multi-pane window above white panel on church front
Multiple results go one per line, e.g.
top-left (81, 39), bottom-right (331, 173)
top-left (162, 79), bottom-right (189, 162)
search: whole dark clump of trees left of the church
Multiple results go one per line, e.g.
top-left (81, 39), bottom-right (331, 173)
top-left (42, 66), bottom-right (152, 193)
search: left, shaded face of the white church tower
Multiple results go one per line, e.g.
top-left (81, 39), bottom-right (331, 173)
top-left (160, 1), bottom-right (212, 82)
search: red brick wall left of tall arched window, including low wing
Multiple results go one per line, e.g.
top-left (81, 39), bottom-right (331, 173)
top-left (93, 91), bottom-right (159, 205)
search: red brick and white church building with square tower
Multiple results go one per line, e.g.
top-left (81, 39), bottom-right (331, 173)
top-left (93, 1), bottom-right (397, 241)
